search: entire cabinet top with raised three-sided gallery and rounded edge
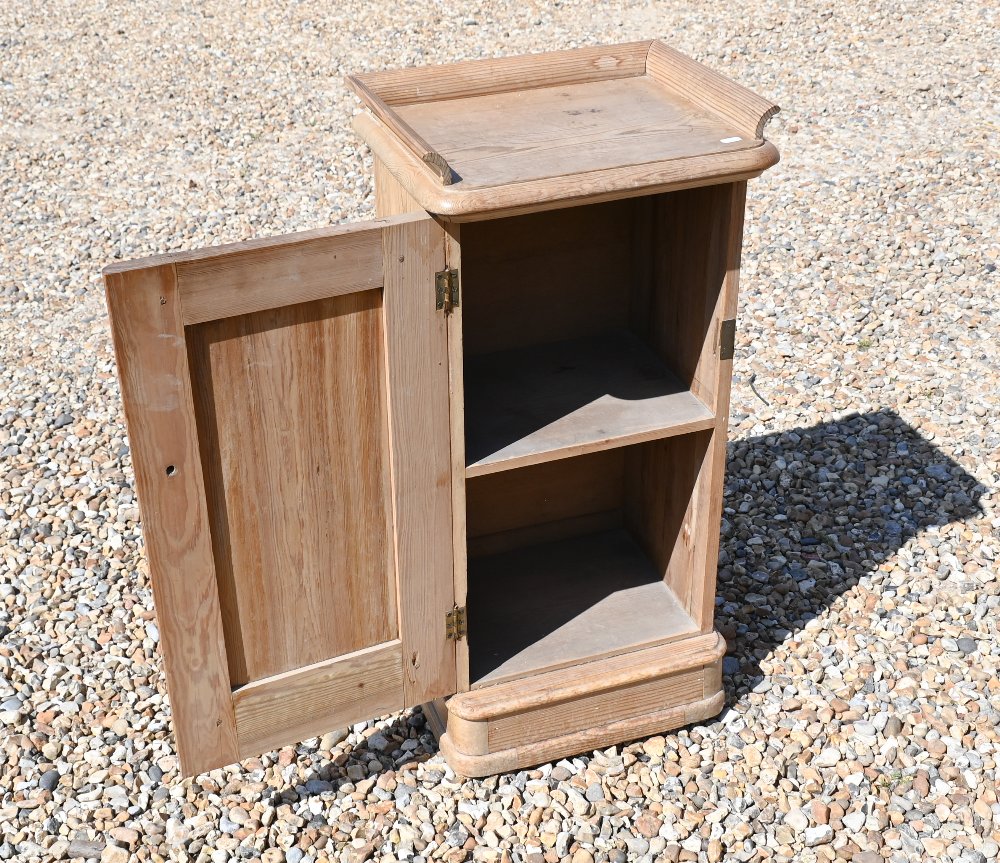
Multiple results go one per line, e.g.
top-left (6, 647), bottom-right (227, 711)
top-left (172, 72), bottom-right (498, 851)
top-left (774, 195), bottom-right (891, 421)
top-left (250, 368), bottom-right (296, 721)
top-left (347, 41), bottom-right (778, 221)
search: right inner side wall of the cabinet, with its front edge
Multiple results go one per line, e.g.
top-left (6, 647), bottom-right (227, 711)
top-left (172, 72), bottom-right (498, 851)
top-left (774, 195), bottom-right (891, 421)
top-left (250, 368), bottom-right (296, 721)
top-left (626, 182), bottom-right (746, 631)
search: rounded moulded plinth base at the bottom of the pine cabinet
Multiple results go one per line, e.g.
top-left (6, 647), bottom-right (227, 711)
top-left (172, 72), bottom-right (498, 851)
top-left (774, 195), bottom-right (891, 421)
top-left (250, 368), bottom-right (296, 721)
top-left (424, 632), bottom-right (725, 776)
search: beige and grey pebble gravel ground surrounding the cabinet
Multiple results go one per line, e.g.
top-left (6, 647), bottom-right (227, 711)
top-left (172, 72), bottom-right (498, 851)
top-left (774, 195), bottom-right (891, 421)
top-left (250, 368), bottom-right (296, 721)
top-left (0, 0), bottom-right (1000, 863)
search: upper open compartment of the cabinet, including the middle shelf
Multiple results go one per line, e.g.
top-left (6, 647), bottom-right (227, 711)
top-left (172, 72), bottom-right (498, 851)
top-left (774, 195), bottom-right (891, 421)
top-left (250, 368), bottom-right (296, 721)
top-left (462, 187), bottom-right (732, 478)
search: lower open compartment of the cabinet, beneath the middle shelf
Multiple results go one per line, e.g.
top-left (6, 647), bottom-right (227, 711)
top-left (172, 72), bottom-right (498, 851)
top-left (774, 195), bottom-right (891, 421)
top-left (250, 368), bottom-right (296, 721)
top-left (466, 438), bottom-right (712, 687)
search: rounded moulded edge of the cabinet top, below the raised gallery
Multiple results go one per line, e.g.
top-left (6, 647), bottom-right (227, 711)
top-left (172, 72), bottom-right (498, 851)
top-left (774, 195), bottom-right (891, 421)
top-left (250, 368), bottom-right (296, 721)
top-left (353, 114), bottom-right (778, 222)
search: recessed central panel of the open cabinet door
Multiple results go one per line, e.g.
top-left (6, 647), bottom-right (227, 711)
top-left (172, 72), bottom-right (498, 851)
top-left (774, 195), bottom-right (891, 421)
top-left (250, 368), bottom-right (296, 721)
top-left (186, 290), bottom-right (398, 687)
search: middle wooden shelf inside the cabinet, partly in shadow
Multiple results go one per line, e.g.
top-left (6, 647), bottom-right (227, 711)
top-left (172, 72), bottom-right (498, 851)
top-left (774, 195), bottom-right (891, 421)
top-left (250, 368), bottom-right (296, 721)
top-left (465, 330), bottom-right (715, 477)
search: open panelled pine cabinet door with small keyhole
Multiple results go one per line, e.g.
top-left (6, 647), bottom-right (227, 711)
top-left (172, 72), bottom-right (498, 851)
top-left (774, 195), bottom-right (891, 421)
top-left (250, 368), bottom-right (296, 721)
top-left (105, 215), bottom-right (455, 774)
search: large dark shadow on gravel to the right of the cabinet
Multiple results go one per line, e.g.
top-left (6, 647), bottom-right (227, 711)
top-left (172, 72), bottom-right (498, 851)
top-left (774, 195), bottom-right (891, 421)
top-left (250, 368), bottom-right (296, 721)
top-left (716, 411), bottom-right (986, 703)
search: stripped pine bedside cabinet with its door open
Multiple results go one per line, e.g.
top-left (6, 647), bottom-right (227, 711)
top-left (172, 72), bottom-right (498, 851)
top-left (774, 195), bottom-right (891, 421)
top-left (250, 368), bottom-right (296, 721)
top-left (105, 41), bottom-right (778, 776)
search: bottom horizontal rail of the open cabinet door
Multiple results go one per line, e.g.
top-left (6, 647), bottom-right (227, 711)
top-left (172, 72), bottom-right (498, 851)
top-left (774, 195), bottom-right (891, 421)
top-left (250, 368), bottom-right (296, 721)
top-left (233, 641), bottom-right (405, 758)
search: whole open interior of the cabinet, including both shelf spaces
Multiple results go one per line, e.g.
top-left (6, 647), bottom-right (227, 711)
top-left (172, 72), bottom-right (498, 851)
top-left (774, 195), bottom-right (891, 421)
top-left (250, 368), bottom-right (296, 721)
top-left (461, 186), bottom-right (742, 686)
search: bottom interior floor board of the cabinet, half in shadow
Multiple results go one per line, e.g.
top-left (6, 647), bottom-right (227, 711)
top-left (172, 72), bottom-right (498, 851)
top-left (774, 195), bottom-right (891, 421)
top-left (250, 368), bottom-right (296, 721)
top-left (468, 529), bottom-right (698, 688)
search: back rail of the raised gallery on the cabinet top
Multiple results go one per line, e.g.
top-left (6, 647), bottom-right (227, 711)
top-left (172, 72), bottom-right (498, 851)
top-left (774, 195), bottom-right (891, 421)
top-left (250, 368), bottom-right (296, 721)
top-left (347, 40), bottom-right (651, 105)
